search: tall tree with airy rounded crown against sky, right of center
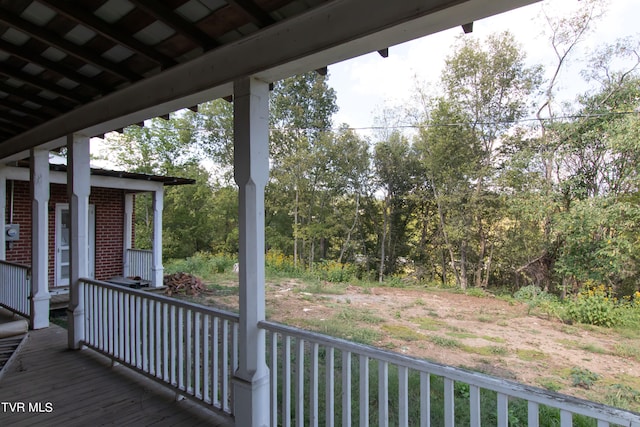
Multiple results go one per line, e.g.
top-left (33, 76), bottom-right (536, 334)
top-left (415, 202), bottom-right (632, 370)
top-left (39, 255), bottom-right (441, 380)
top-left (441, 32), bottom-right (540, 287)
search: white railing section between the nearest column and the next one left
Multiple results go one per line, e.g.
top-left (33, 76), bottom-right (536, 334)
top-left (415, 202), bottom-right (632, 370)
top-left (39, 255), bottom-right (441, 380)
top-left (81, 279), bottom-right (239, 415)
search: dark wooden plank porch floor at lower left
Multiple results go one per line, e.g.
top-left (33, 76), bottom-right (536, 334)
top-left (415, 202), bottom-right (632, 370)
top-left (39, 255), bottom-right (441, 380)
top-left (0, 325), bottom-right (233, 427)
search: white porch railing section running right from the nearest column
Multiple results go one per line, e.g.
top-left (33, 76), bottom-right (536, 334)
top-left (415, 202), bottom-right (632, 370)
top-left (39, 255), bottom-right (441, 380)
top-left (260, 322), bottom-right (640, 427)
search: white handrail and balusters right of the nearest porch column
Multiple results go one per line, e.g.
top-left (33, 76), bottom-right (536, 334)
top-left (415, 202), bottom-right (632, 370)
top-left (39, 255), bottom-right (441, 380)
top-left (259, 321), bottom-right (640, 427)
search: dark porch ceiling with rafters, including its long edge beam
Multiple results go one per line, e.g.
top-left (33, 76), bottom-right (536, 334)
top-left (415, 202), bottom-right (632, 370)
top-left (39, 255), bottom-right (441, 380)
top-left (0, 0), bottom-right (538, 160)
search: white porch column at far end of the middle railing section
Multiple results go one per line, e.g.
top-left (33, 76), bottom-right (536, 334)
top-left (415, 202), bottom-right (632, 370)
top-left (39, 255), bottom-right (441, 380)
top-left (67, 135), bottom-right (91, 350)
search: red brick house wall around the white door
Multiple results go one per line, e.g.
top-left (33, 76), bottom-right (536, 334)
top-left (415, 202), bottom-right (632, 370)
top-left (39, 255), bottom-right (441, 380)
top-left (6, 181), bottom-right (124, 286)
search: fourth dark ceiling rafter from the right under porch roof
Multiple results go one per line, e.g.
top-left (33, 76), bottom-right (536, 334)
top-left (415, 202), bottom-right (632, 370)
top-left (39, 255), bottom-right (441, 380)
top-left (0, 7), bottom-right (141, 81)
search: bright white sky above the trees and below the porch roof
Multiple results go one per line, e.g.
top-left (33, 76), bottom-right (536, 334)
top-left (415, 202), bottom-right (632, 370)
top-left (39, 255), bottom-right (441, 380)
top-left (329, 0), bottom-right (640, 134)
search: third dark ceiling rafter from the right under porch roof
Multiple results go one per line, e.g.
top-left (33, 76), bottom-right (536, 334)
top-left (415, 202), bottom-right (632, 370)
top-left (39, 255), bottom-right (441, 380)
top-left (39, 0), bottom-right (177, 68)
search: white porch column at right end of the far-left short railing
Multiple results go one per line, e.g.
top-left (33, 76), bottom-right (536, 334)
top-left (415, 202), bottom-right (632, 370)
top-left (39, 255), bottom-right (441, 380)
top-left (30, 149), bottom-right (51, 329)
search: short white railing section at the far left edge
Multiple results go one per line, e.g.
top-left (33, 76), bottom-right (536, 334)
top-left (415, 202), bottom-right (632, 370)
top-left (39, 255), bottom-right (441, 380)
top-left (0, 261), bottom-right (31, 318)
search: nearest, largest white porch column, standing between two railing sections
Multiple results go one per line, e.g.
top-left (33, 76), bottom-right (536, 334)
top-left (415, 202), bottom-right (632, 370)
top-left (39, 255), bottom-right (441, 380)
top-left (233, 78), bottom-right (269, 427)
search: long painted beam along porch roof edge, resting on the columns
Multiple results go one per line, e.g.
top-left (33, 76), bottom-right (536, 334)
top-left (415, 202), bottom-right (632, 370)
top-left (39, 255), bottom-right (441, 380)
top-left (0, 0), bottom-right (538, 159)
